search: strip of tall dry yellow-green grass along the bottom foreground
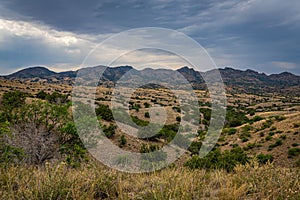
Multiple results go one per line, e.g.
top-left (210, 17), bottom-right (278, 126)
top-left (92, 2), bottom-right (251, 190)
top-left (0, 163), bottom-right (300, 199)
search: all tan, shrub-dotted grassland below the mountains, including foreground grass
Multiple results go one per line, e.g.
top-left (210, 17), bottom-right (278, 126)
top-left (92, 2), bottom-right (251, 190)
top-left (0, 76), bottom-right (300, 199)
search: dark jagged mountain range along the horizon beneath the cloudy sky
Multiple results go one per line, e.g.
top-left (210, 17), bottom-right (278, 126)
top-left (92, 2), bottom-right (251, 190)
top-left (2, 65), bottom-right (300, 95)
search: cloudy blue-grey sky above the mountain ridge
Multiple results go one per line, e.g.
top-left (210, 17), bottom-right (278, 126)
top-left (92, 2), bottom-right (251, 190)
top-left (0, 0), bottom-right (300, 75)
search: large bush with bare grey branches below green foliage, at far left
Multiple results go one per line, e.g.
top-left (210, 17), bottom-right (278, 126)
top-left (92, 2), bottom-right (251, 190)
top-left (5, 101), bottom-right (70, 165)
